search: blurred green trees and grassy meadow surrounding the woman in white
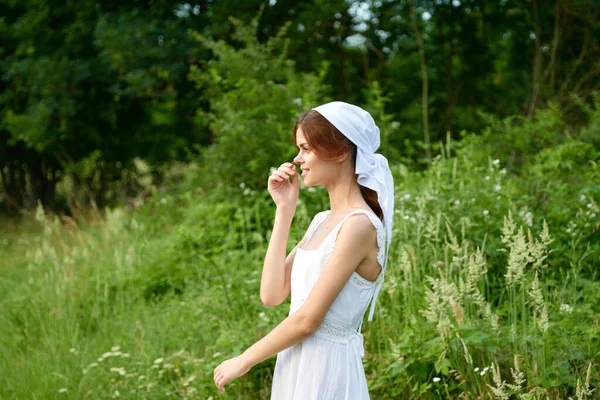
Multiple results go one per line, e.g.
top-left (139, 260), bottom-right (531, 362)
top-left (0, 0), bottom-right (600, 399)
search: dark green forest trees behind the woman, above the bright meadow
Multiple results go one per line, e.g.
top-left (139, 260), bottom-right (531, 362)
top-left (0, 0), bottom-right (600, 213)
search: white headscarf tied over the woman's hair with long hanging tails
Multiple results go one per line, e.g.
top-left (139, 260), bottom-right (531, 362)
top-left (313, 101), bottom-right (394, 321)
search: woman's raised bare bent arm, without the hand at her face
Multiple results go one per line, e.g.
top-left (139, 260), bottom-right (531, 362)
top-left (260, 207), bottom-right (306, 306)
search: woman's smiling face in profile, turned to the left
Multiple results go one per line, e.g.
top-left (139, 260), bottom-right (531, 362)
top-left (294, 127), bottom-right (340, 186)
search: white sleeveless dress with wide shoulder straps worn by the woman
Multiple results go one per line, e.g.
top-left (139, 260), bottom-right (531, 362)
top-left (271, 209), bottom-right (385, 400)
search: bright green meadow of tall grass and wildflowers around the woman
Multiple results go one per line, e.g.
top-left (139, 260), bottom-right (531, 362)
top-left (0, 102), bottom-right (600, 400)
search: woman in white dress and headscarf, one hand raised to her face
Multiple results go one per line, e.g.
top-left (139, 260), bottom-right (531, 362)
top-left (214, 101), bottom-right (394, 400)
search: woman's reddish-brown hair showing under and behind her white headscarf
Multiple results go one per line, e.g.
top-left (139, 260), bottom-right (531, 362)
top-left (293, 110), bottom-right (383, 220)
